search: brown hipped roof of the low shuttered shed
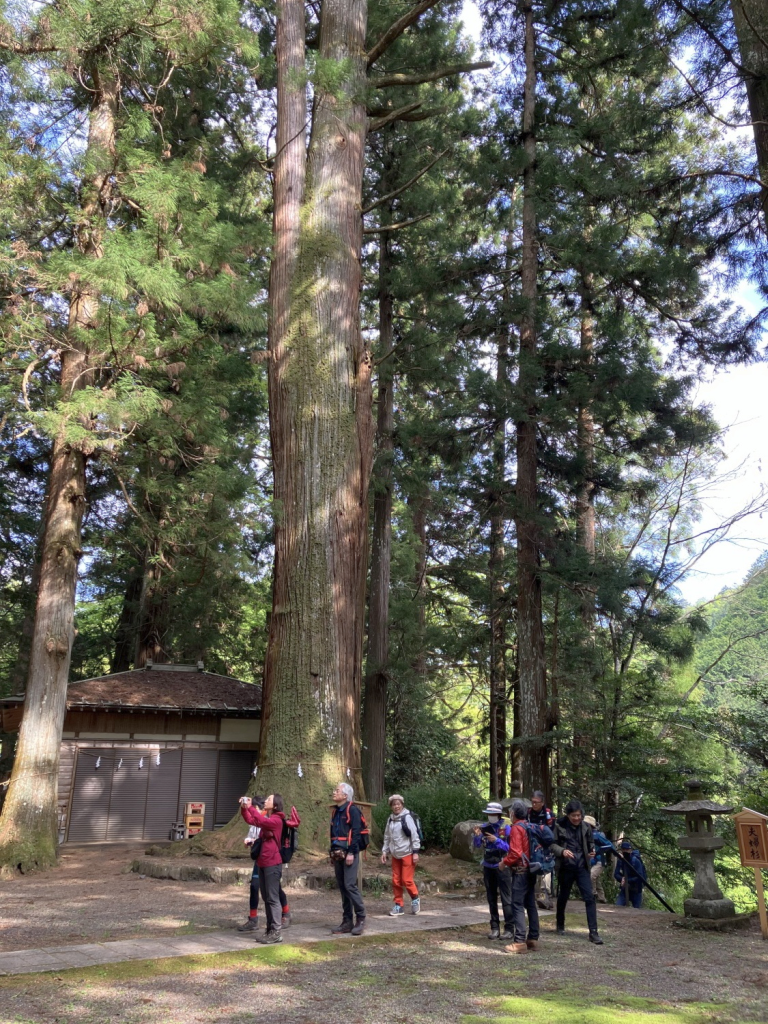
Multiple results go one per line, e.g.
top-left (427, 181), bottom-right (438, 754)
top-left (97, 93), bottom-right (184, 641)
top-left (3, 667), bottom-right (261, 714)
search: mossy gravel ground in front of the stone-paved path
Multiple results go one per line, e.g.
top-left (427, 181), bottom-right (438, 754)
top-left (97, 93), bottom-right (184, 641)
top-left (0, 911), bottom-right (768, 1024)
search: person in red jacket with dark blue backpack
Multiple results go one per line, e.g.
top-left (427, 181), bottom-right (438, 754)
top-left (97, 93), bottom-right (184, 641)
top-left (503, 800), bottom-right (554, 953)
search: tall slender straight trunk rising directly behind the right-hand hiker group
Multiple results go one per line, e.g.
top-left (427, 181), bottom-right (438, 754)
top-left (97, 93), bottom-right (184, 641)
top-left (514, 0), bottom-right (550, 796)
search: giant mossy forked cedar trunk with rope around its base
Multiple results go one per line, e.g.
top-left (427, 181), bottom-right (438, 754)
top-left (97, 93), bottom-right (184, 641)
top-left (258, 0), bottom-right (373, 844)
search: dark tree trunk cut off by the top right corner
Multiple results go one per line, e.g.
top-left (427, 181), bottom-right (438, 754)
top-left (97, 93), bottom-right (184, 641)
top-left (731, 0), bottom-right (768, 233)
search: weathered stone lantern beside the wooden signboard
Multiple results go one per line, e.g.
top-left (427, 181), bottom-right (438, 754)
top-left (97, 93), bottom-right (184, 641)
top-left (662, 779), bottom-right (736, 920)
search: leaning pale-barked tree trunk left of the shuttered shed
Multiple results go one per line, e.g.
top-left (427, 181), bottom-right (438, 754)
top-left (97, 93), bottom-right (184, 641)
top-left (0, 73), bottom-right (118, 877)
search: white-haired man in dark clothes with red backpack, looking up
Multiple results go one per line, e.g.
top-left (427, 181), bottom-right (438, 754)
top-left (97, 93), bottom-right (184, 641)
top-left (330, 782), bottom-right (370, 935)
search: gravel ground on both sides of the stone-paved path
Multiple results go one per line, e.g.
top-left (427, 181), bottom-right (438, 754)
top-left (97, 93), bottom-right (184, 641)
top-left (0, 844), bottom-right (768, 1024)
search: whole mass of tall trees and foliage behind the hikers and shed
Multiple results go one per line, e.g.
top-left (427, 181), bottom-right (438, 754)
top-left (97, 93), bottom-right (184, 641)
top-left (0, 0), bottom-right (768, 897)
